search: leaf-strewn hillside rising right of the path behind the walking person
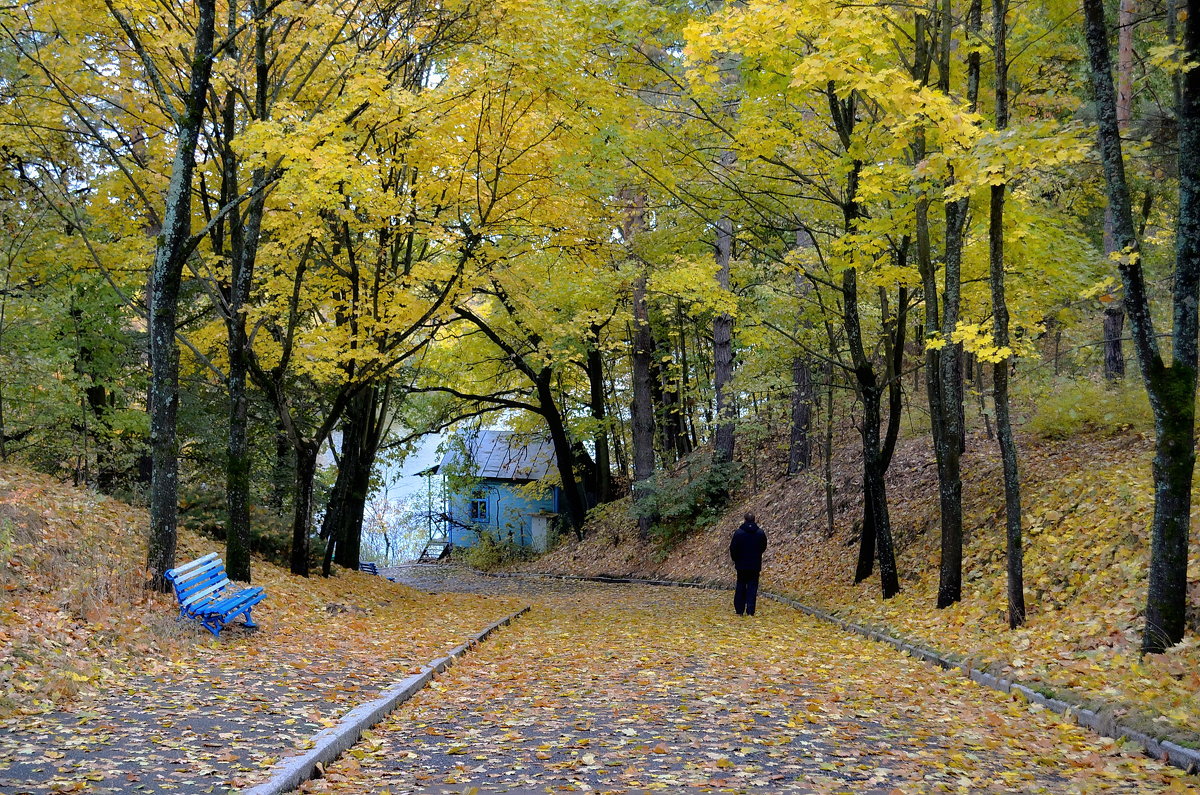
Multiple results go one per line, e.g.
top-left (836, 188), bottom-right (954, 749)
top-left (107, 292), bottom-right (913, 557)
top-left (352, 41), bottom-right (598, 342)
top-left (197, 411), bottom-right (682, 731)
top-left (526, 434), bottom-right (1200, 745)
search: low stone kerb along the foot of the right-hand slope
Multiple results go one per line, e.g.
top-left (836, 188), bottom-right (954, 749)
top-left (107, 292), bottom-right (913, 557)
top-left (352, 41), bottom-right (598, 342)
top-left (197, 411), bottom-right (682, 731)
top-left (481, 572), bottom-right (1200, 773)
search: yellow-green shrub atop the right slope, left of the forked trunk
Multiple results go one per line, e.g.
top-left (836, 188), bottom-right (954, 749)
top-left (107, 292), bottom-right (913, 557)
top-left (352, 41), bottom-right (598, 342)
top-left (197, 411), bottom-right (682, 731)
top-left (1028, 376), bottom-right (1154, 438)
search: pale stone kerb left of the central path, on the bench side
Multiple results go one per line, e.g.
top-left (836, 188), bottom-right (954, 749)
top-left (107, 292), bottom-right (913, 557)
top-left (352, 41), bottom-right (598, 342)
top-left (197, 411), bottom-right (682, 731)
top-left (242, 605), bottom-right (529, 795)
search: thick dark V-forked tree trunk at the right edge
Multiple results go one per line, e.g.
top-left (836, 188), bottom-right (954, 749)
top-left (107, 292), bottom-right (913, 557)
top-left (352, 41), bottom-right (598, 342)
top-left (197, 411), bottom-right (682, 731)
top-left (1084, 0), bottom-right (1200, 653)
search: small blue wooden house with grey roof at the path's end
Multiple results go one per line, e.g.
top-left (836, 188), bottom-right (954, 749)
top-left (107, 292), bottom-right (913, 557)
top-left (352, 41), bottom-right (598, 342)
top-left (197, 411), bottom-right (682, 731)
top-left (438, 430), bottom-right (562, 552)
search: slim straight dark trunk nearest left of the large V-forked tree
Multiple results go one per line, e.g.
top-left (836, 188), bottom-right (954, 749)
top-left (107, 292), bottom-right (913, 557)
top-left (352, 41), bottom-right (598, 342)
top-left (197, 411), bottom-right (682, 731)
top-left (988, 0), bottom-right (1025, 629)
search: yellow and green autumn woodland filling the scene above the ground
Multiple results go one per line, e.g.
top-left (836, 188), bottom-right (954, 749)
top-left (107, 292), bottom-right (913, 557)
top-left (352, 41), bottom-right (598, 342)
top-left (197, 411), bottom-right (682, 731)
top-left (0, 0), bottom-right (1200, 715)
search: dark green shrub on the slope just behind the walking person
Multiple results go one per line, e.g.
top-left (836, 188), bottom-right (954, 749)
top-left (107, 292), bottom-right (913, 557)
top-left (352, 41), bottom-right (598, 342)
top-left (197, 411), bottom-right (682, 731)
top-left (632, 461), bottom-right (742, 549)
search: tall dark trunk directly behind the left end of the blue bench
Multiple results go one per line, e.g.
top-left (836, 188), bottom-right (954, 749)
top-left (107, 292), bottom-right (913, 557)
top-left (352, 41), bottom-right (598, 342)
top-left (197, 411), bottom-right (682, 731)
top-left (146, 0), bottom-right (216, 591)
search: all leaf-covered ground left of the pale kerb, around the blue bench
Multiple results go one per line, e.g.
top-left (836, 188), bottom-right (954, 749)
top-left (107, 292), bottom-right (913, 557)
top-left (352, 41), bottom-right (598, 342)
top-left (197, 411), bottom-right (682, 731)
top-left (0, 470), bottom-right (520, 793)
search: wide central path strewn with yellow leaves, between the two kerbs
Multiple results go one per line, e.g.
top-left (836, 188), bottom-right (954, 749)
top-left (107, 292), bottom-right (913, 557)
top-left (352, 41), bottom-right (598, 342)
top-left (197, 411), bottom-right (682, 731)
top-left (304, 580), bottom-right (1196, 794)
